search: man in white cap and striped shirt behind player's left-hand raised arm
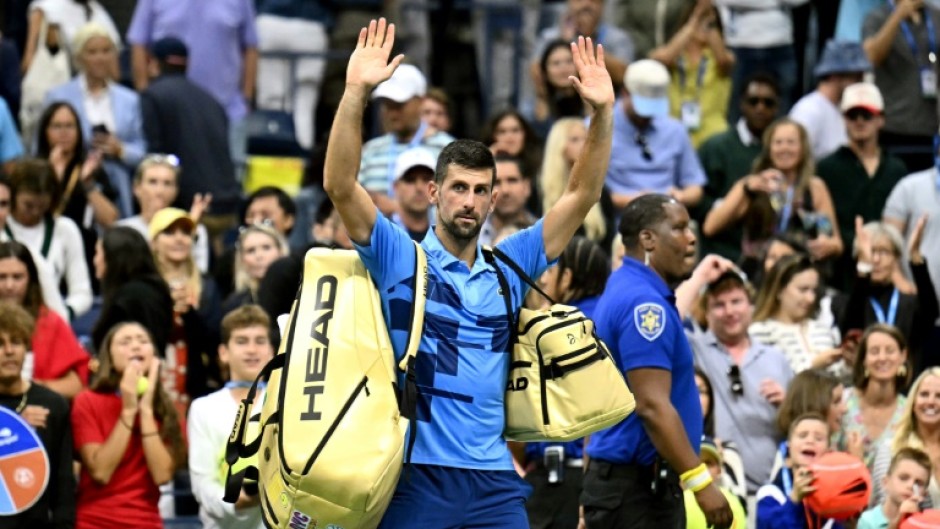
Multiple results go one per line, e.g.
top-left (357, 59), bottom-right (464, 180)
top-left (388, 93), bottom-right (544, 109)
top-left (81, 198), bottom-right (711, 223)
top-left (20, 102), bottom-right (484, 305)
top-left (359, 64), bottom-right (454, 215)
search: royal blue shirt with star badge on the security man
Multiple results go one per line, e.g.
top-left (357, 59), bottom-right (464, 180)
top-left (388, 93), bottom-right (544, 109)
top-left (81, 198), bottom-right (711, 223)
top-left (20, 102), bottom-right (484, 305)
top-left (587, 257), bottom-right (703, 465)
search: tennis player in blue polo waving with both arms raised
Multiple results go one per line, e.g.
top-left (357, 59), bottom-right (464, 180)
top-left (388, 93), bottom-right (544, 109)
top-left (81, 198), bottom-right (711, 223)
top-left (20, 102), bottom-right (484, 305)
top-left (323, 19), bottom-right (614, 529)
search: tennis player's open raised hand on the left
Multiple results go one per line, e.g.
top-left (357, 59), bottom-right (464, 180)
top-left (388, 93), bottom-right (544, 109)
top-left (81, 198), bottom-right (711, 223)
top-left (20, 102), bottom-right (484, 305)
top-left (346, 18), bottom-right (405, 91)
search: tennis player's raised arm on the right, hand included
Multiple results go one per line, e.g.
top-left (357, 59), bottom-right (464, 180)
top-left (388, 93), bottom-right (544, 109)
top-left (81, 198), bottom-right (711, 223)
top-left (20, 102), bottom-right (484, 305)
top-left (542, 37), bottom-right (614, 260)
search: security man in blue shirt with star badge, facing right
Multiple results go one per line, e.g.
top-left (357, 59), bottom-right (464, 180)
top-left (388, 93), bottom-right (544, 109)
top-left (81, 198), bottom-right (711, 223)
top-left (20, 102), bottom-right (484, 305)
top-left (581, 195), bottom-right (732, 529)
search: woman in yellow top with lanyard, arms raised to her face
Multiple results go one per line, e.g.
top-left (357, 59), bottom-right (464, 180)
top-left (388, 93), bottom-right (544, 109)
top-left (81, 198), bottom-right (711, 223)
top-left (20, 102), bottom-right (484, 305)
top-left (650, 2), bottom-right (734, 148)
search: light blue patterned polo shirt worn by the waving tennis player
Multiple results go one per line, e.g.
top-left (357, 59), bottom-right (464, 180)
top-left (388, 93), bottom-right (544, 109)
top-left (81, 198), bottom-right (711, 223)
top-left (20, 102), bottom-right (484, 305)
top-left (356, 213), bottom-right (549, 470)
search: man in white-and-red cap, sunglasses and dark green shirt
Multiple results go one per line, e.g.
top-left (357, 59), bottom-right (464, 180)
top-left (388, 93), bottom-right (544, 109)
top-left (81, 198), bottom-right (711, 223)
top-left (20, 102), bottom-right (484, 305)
top-left (816, 83), bottom-right (907, 289)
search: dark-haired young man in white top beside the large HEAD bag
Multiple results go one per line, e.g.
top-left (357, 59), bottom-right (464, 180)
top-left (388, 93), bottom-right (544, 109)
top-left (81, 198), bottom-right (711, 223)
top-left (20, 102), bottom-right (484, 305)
top-left (187, 305), bottom-right (274, 529)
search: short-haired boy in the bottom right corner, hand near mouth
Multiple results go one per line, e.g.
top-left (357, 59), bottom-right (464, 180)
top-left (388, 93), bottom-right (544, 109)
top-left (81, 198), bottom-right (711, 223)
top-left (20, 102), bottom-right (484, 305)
top-left (857, 447), bottom-right (931, 529)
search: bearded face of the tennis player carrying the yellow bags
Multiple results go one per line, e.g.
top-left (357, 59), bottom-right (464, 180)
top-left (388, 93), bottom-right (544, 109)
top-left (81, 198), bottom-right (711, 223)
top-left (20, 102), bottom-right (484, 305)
top-left (431, 164), bottom-right (499, 242)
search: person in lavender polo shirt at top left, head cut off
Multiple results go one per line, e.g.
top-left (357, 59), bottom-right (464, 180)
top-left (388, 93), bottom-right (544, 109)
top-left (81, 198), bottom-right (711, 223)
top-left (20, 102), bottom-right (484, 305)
top-left (127, 0), bottom-right (258, 124)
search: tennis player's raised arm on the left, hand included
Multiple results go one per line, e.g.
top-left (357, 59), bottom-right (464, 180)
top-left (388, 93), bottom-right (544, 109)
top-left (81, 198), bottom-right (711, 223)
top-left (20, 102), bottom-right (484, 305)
top-left (323, 18), bottom-right (404, 244)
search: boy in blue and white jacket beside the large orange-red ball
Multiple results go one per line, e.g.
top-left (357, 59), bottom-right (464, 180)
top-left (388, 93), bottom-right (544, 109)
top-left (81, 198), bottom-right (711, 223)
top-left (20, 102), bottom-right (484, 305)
top-left (757, 413), bottom-right (841, 529)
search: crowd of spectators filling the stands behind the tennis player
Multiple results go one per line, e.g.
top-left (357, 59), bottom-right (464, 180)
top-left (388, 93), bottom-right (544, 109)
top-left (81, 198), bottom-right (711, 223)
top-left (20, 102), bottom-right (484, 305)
top-left (0, 0), bottom-right (940, 529)
